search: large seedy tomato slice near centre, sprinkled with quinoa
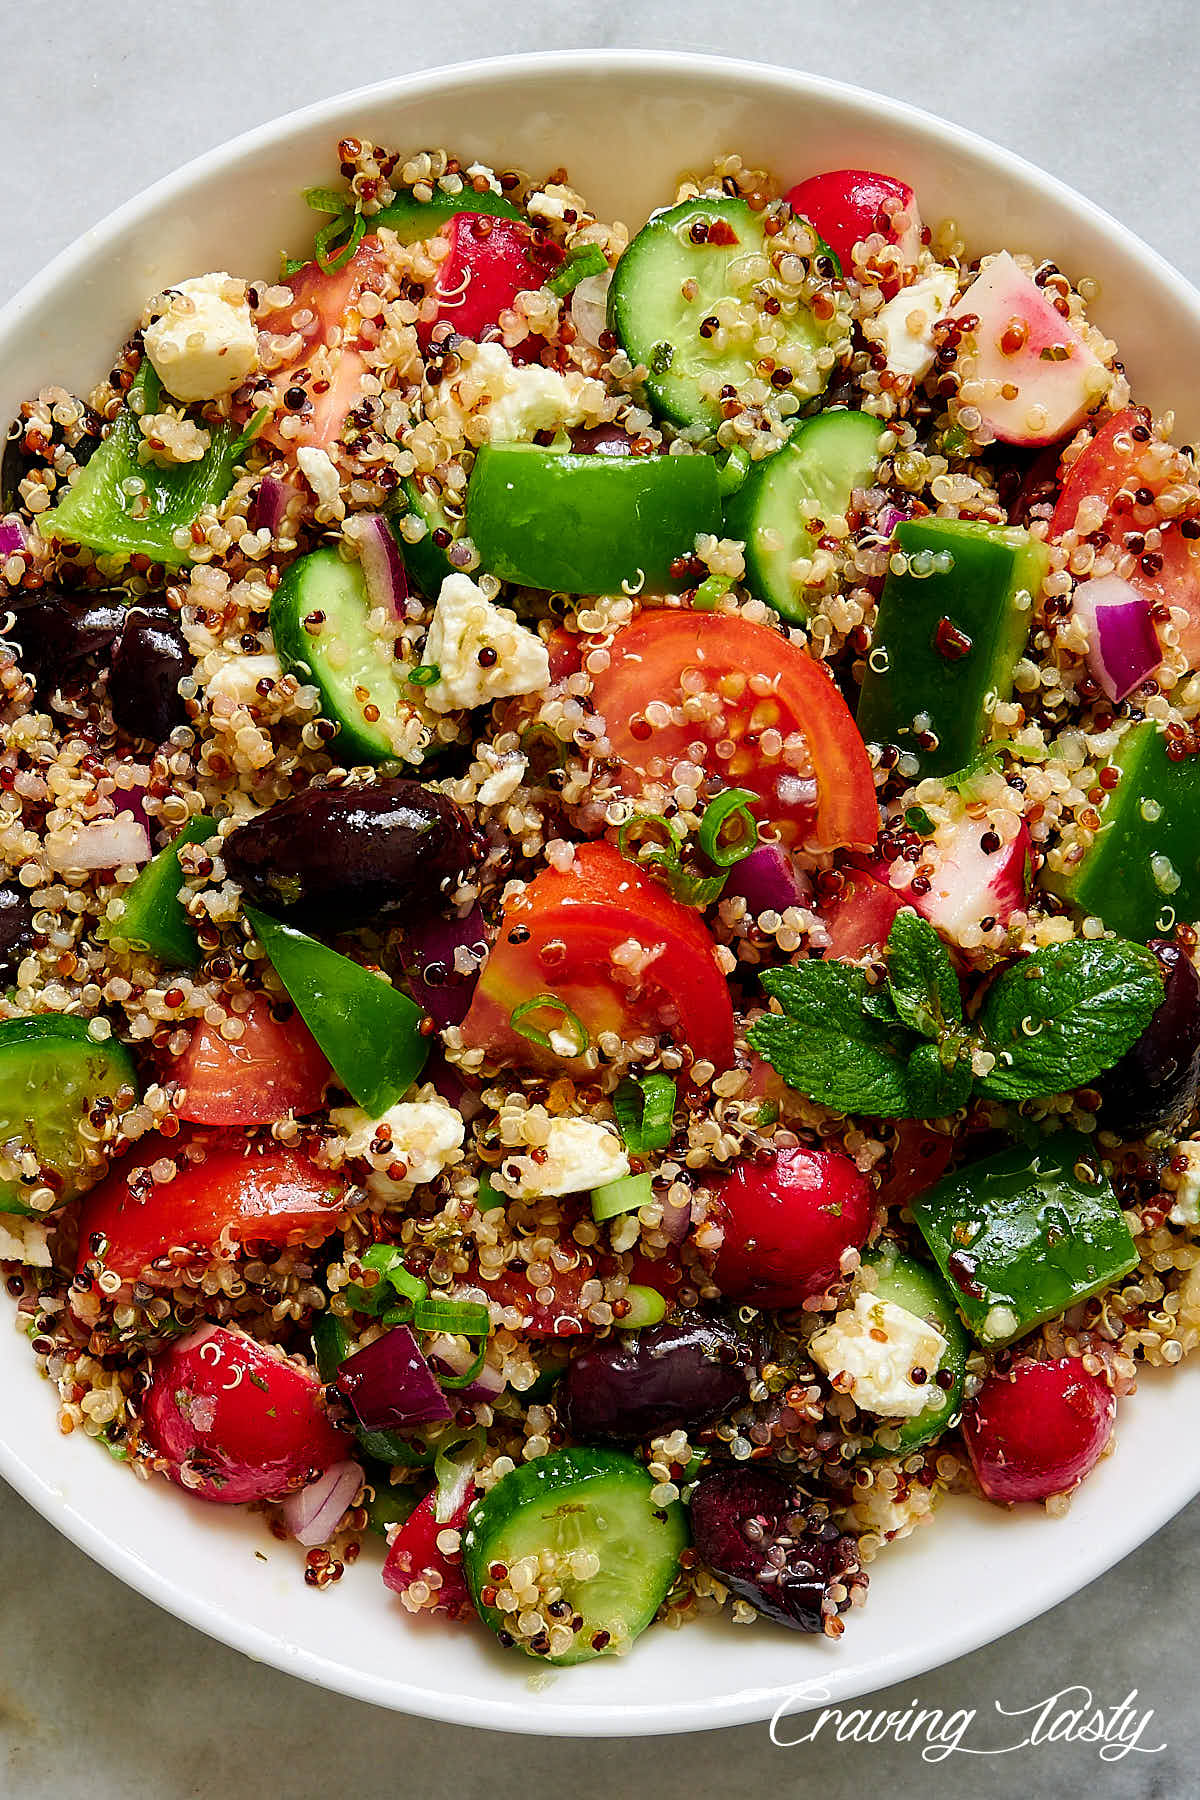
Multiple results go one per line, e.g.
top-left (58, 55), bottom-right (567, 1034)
top-left (592, 608), bottom-right (880, 850)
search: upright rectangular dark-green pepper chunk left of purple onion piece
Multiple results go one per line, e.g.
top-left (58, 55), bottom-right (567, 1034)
top-left (858, 518), bottom-right (1049, 776)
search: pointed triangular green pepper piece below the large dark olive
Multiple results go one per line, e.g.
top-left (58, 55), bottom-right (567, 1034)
top-left (245, 905), bottom-right (430, 1118)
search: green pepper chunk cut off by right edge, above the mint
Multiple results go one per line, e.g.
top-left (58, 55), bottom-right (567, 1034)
top-left (1042, 718), bottom-right (1200, 943)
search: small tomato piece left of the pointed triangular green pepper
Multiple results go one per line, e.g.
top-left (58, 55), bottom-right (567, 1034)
top-left (169, 994), bottom-right (333, 1125)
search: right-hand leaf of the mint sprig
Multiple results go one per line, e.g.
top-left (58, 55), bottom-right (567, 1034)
top-left (979, 938), bottom-right (1162, 1100)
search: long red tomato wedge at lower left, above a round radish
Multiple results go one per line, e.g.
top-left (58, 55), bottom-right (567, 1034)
top-left (77, 1132), bottom-right (345, 1282)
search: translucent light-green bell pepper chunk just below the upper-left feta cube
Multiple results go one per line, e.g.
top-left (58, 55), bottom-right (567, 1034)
top-left (40, 360), bottom-right (246, 569)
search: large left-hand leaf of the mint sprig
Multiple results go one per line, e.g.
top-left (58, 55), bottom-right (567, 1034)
top-left (747, 963), bottom-right (912, 1118)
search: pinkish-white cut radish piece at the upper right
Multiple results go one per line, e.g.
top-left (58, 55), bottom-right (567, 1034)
top-left (952, 250), bottom-right (1110, 445)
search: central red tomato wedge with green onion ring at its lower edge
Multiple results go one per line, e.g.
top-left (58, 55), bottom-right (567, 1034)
top-left (462, 842), bottom-right (734, 1069)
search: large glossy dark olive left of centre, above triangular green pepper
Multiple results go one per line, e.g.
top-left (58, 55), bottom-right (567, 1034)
top-left (223, 776), bottom-right (482, 927)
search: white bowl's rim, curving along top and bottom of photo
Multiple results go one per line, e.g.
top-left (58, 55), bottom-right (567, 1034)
top-left (0, 49), bottom-right (1200, 1737)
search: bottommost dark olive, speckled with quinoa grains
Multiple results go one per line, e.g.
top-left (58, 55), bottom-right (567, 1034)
top-left (691, 1465), bottom-right (865, 1636)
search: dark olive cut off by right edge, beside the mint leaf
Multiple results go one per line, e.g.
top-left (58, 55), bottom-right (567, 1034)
top-left (1096, 938), bottom-right (1200, 1138)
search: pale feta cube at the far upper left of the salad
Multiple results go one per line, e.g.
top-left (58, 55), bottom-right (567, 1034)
top-left (144, 272), bottom-right (259, 403)
